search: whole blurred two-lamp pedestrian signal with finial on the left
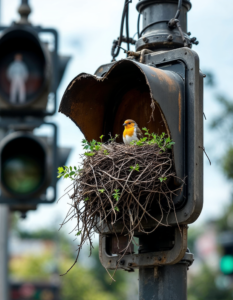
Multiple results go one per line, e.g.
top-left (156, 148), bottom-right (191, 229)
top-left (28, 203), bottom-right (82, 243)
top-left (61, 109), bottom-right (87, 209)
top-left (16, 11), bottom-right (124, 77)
top-left (0, 3), bottom-right (71, 211)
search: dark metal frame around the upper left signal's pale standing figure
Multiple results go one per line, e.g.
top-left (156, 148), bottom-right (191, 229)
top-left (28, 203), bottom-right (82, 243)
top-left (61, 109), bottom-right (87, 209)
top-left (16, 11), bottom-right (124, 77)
top-left (0, 23), bottom-right (59, 117)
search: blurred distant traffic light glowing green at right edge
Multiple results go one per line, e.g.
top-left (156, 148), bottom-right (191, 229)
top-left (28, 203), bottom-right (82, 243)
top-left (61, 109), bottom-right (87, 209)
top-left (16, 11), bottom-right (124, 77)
top-left (219, 231), bottom-right (233, 275)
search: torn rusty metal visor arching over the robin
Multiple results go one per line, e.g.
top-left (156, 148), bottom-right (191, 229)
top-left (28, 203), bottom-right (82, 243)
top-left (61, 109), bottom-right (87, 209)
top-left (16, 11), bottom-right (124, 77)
top-left (59, 60), bottom-right (184, 182)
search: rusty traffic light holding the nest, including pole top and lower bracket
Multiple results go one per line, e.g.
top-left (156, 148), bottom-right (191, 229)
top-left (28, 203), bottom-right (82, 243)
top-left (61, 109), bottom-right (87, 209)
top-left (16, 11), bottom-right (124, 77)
top-left (59, 0), bottom-right (204, 271)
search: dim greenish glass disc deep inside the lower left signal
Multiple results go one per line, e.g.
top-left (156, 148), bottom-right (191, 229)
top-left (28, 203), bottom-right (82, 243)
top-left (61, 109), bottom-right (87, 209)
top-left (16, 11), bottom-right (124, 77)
top-left (3, 155), bottom-right (43, 194)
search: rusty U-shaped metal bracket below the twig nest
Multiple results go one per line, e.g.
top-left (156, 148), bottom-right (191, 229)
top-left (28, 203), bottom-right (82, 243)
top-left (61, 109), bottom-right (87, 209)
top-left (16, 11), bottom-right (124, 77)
top-left (99, 225), bottom-right (187, 270)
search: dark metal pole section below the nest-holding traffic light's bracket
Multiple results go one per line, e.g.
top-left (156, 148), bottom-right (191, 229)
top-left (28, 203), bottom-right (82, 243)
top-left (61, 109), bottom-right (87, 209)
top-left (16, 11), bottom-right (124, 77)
top-left (139, 253), bottom-right (193, 300)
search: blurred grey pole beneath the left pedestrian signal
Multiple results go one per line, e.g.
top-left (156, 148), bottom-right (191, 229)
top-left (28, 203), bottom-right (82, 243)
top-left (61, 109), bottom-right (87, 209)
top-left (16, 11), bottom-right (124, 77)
top-left (0, 205), bottom-right (9, 300)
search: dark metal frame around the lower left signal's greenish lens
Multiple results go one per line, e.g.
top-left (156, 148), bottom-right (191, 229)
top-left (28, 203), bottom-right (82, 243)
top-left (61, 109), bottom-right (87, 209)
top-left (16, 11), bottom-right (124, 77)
top-left (0, 119), bottom-right (58, 207)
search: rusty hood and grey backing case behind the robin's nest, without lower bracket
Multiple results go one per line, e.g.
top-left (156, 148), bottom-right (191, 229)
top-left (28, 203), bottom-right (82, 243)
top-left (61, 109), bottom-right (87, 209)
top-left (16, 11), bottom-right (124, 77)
top-left (59, 48), bottom-right (203, 225)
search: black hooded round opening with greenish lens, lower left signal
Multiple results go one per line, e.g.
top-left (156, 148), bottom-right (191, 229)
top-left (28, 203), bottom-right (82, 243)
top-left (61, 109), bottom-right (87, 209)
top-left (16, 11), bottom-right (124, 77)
top-left (1, 136), bottom-right (46, 198)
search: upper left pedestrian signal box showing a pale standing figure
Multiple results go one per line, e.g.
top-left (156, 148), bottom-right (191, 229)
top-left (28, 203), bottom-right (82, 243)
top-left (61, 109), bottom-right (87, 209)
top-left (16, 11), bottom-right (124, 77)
top-left (0, 26), bottom-right (59, 116)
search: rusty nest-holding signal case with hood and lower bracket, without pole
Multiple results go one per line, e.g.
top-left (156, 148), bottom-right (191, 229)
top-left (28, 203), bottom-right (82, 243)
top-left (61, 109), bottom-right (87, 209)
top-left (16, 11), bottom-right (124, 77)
top-left (59, 47), bottom-right (203, 269)
